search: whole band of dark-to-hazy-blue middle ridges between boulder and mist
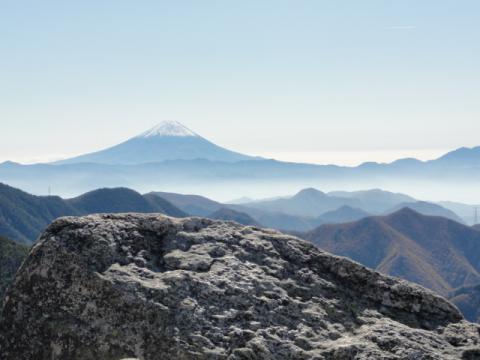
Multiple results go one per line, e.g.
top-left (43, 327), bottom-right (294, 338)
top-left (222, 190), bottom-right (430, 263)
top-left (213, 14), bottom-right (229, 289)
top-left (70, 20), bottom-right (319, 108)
top-left (0, 184), bottom-right (470, 243)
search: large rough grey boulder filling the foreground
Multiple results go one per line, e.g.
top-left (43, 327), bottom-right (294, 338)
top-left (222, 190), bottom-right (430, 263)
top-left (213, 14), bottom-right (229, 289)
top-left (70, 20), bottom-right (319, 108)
top-left (0, 214), bottom-right (480, 360)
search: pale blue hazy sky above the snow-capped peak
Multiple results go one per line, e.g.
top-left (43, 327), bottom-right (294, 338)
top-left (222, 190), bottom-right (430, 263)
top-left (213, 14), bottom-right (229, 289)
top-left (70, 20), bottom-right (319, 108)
top-left (0, 0), bottom-right (480, 164)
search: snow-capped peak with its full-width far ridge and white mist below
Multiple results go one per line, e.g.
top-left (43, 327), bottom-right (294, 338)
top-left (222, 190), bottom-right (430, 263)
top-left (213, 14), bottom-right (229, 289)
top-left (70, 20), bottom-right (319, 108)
top-left (0, 122), bottom-right (480, 201)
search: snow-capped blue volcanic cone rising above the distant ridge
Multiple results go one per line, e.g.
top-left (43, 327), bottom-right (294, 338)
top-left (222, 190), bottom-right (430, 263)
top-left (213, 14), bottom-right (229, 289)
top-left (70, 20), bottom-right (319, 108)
top-left (54, 121), bottom-right (259, 165)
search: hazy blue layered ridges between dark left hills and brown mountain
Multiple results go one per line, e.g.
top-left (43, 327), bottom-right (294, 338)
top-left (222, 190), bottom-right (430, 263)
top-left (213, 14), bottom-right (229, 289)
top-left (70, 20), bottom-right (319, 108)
top-left (152, 188), bottom-right (468, 232)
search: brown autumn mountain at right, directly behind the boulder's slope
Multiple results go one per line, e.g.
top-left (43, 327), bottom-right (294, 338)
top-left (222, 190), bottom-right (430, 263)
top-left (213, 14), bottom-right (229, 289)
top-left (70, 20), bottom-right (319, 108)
top-left (303, 208), bottom-right (480, 321)
